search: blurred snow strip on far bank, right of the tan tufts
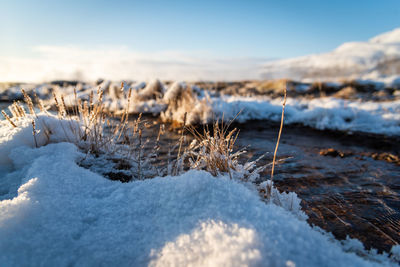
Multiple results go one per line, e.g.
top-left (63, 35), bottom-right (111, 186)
top-left (210, 96), bottom-right (400, 136)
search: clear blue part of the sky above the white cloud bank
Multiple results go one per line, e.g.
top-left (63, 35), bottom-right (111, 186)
top-left (0, 0), bottom-right (400, 58)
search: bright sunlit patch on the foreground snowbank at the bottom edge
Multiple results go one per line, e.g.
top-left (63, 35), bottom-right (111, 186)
top-left (149, 221), bottom-right (262, 266)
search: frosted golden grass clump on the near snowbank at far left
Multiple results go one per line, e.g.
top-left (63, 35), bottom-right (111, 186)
top-left (2, 84), bottom-right (161, 179)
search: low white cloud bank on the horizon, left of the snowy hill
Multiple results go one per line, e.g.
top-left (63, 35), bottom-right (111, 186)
top-left (0, 46), bottom-right (265, 82)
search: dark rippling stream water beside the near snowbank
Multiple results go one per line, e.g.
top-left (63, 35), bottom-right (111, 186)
top-left (145, 118), bottom-right (400, 254)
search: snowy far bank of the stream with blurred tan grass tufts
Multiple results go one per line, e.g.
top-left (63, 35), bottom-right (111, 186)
top-left (0, 80), bottom-right (400, 136)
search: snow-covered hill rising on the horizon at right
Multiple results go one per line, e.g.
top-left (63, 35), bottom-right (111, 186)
top-left (262, 28), bottom-right (400, 83)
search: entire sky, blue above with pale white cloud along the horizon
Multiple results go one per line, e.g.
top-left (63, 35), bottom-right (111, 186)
top-left (0, 0), bottom-right (400, 81)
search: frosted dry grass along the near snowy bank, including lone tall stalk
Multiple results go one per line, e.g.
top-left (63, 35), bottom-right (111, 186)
top-left (2, 84), bottom-right (286, 186)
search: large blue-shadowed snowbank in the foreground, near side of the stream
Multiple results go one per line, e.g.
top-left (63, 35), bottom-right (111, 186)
top-left (0, 114), bottom-right (400, 266)
